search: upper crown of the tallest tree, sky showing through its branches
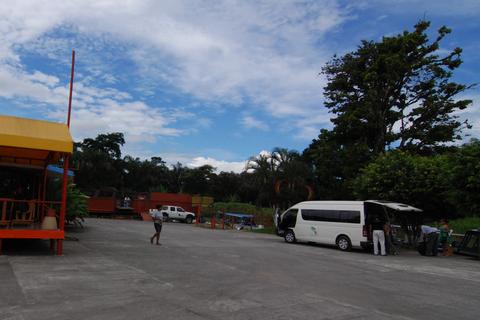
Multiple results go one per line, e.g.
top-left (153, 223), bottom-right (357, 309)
top-left (323, 21), bottom-right (472, 155)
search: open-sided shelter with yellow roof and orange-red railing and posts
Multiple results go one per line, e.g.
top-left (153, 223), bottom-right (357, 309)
top-left (0, 116), bottom-right (73, 255)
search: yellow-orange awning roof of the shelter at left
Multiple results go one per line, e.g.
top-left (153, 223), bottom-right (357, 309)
top-left (0, 116), bottom-right (73, 166)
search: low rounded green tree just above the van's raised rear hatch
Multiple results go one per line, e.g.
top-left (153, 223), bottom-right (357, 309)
top-left (353, 149), bottom-right (456, 217)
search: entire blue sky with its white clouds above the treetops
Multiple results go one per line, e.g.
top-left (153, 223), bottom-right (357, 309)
top-left (0, 0), bottom-right (480, 172)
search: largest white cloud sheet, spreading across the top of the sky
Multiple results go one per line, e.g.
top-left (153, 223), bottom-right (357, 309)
top-left (0, 0), bottom-right (345, 140)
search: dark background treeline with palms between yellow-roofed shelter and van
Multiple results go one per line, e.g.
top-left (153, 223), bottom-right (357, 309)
top-left (73, 133), bottom-right (313, 206)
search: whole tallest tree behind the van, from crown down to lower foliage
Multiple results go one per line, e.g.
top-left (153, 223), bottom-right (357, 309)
top-left (304, 21), bottom-right (472, 199)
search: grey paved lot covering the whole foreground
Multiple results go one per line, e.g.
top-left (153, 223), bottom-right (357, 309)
top-left (0, 219), bottom-right (480, 320)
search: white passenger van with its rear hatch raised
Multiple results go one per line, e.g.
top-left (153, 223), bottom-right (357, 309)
top-left (275, 200), bottom-right (422, 251)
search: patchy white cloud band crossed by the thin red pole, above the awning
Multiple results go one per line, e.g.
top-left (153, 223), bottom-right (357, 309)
top-left (0, 64), bottom-right (184, 143)
